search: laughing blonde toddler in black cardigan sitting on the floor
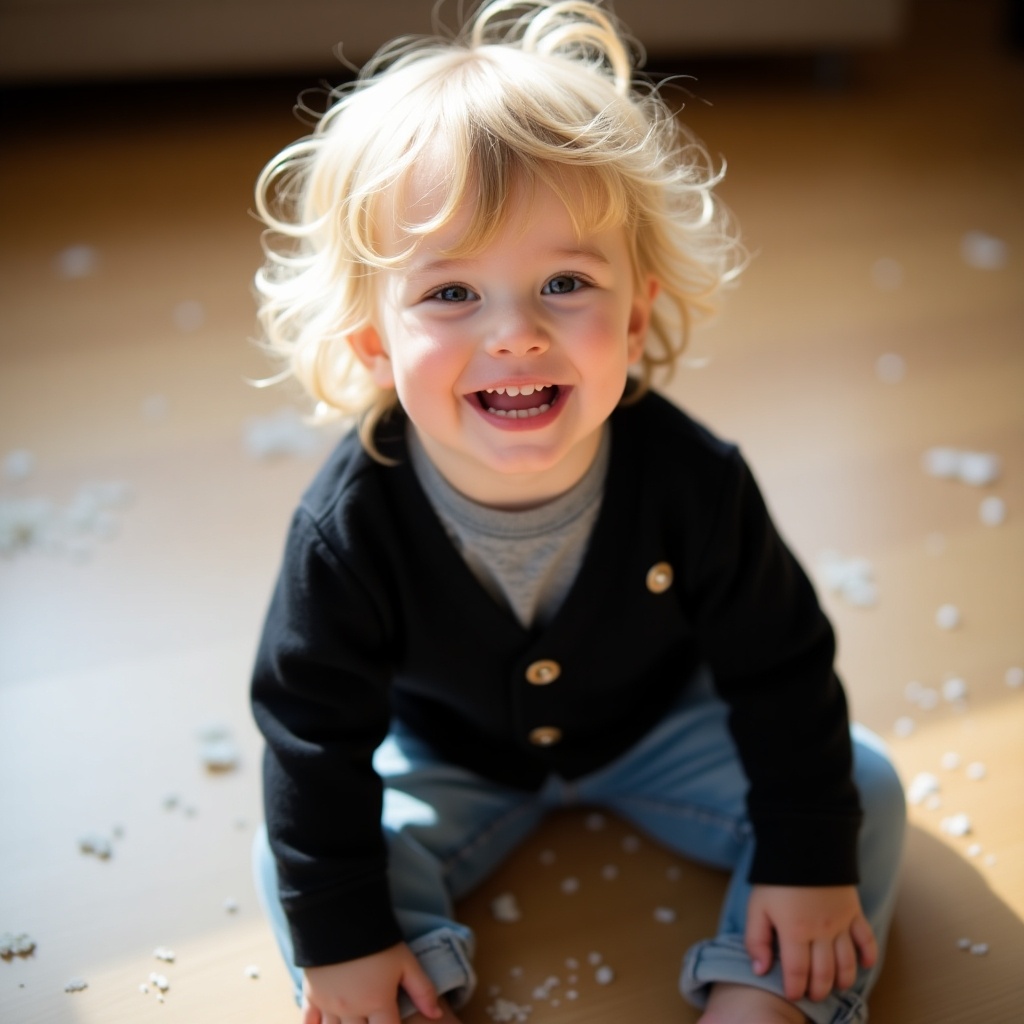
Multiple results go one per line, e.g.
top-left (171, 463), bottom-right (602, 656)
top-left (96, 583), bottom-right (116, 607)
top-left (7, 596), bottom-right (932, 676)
top-left (252, 0), bottom-right (904, 1024)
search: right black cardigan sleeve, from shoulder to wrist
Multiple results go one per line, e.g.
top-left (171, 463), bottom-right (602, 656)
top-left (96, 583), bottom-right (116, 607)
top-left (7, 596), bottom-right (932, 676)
top-left (695, 453), bottom-right (861, 886)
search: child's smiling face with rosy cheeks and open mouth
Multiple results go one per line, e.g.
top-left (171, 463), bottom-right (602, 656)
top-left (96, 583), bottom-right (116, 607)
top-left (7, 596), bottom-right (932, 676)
top-left (351, 184), bottom-right (656, 508)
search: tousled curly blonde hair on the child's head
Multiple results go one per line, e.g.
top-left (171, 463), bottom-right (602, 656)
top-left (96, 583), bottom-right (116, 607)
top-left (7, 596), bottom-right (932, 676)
top-left (256, 0), bottom-right (744, 451)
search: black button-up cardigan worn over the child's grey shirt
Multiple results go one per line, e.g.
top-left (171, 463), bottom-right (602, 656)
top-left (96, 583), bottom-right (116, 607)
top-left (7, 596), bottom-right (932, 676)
top-left (252, 394), bottom-right (860, 967)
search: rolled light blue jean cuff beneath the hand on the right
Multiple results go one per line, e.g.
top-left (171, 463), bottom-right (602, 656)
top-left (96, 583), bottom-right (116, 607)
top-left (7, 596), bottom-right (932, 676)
top-left (679, 935), bottom-right (867, 1024)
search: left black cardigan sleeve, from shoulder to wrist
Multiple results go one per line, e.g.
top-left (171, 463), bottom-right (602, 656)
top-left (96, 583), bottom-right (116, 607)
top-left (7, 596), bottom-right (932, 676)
top-left (252, 510), bottom-right (401, 967)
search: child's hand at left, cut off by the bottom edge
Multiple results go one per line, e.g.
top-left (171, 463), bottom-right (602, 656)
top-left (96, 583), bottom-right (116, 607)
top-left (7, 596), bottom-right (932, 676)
top-left (302, 942), bottom-right (441, 1024)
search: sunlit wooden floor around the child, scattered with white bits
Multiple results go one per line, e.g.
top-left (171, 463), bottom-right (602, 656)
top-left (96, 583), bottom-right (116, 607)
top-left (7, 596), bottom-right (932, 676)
top-left (0, 0), bottom-right (1024, 1024)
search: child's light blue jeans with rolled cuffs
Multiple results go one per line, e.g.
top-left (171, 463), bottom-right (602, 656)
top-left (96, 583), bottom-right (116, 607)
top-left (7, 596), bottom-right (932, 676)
top-left (254, 674), bottom-right (905, 1024)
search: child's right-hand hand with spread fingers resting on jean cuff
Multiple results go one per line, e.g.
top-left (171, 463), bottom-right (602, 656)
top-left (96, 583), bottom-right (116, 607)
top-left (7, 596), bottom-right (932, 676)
top-left (744, 886), bottom-right (878, 1000)
